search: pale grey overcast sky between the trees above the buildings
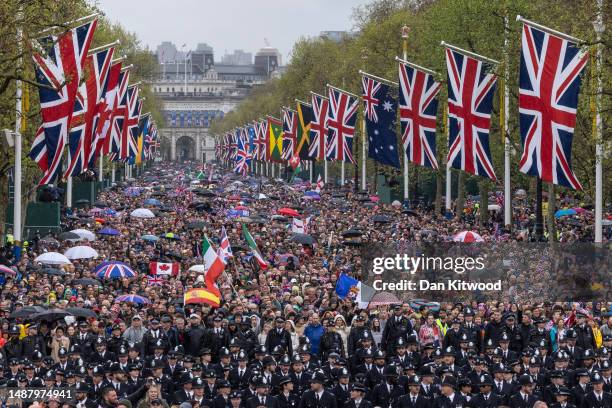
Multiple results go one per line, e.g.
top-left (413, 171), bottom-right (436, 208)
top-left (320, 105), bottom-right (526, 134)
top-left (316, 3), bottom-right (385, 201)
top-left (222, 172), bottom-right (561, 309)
top-left (97, 0), bottom-right (369, 63)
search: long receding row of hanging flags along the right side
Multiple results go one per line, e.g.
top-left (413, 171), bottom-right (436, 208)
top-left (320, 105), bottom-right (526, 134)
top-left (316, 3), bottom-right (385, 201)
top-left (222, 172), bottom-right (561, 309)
top-left (216, 20), bottom-right (588, 189)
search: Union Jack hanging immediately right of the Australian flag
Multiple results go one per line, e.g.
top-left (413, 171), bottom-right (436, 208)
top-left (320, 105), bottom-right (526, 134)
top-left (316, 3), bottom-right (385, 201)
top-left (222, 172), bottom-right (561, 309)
top-left (399, 63), bottom-right (441, 169)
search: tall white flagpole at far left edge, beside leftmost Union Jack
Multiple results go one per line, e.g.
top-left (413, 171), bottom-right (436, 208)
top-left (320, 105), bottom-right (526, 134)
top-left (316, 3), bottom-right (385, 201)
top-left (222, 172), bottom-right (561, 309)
top-left (13, 6), bottom-right (23, 245)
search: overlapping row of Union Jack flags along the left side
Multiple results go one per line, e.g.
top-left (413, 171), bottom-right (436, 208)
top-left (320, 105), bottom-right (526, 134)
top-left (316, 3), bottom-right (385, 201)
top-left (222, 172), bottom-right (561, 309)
top-left (29, 18), bottom-right (160, 185)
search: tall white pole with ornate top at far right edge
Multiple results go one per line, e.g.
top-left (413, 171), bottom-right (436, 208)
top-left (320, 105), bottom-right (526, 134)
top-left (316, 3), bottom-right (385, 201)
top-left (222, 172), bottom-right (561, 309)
top-left (593, 0), bottom-right (606, 243)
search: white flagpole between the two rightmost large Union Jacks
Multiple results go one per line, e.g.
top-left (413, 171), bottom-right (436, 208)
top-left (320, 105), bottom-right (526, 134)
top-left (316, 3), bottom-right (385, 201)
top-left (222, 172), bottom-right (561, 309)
top-left (499, 12), bottom-right (512, 227)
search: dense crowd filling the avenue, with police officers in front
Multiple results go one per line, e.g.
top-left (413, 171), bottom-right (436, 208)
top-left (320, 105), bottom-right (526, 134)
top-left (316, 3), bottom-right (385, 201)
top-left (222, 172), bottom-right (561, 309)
top-left (0, 163), bottom-right (612, 408)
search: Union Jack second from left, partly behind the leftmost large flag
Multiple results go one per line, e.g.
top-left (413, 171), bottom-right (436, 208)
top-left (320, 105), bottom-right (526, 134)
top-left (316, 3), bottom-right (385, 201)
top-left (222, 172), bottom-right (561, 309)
top-left (64, 48), bottom-right (114, 177)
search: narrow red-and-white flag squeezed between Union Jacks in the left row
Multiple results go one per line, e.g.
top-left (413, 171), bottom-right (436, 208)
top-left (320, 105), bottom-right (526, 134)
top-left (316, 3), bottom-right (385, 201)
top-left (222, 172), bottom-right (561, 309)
top-left (95, 62), bottom-right (121, 155)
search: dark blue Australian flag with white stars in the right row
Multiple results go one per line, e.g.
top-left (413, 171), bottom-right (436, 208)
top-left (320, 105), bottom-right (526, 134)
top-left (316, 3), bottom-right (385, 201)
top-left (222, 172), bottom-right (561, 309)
top-left (361, 75), bottom-right (400, 168)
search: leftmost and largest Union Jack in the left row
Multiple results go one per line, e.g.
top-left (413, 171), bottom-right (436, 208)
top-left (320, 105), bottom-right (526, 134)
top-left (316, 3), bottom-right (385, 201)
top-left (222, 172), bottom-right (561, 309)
top-left (29, 20), bottom-right (97, 185)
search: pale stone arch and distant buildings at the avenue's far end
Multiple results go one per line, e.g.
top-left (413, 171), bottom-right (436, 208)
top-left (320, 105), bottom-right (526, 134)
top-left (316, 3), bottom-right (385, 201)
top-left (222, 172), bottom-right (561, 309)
top-left (151, 41), bottom-right (283, 161)
